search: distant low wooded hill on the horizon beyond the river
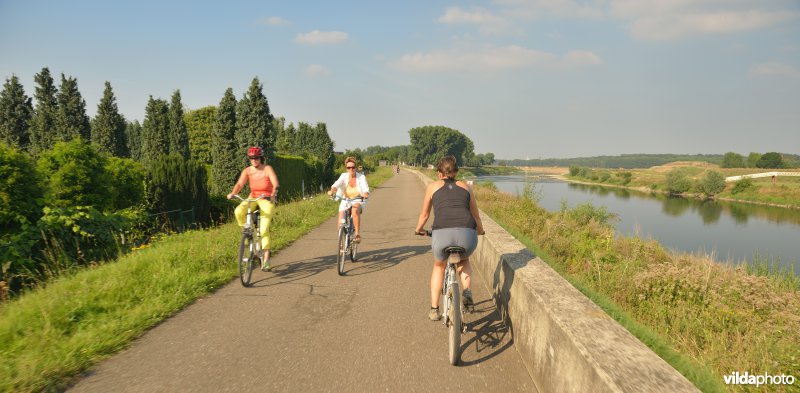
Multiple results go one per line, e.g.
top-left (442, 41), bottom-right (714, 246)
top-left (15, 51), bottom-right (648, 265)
top-left (497, 153), bottom-right (800, 169)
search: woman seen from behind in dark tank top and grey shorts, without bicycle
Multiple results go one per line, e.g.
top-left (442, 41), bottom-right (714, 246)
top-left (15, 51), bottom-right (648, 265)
top-left (415, 156), bottom-right (483, 321)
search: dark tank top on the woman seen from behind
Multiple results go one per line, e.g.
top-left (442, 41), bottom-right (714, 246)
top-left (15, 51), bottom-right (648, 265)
top-left (431, 179), bottom-right (478, 230)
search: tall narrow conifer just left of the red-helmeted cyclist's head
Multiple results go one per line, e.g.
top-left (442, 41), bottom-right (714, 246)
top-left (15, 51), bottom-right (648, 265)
top-left (211, 88), bottom-right (241, 195)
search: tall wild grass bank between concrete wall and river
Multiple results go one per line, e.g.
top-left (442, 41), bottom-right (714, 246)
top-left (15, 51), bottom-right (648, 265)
top-left (476, 187), bottom-right (800, 391)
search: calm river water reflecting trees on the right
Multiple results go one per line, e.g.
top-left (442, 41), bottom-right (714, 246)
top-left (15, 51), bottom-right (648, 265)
top-left (477, 176), bottom-right (800, 275)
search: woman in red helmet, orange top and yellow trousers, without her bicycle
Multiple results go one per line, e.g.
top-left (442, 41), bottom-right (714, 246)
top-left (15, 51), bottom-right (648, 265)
top-left (228, 147), bottom-right (278, 270)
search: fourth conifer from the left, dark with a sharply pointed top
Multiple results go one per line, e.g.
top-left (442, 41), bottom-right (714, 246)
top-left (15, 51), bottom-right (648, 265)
top-left (92, 81), bottom-right (128, 157)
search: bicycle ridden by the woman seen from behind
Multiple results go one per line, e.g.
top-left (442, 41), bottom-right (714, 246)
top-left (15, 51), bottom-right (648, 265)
top-left (415, 231), bottom-right (467, 366)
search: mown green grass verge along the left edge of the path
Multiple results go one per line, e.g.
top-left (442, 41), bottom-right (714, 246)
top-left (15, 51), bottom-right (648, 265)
top-left (0, 168), bottom-right (392, 392)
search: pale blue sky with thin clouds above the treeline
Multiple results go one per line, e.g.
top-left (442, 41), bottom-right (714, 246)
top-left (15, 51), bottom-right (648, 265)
top-left (0, 0), bottom-right (800, 159)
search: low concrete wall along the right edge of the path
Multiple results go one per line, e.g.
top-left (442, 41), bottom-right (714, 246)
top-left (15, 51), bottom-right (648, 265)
top-left (417, 172), bottom-right (698, 392)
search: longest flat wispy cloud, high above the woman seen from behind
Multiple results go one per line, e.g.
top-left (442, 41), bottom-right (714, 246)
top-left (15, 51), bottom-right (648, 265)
top-left (390, 45), bottom-right (603, 72)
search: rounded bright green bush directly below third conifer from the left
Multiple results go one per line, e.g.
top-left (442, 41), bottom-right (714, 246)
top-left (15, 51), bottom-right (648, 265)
top-left (38, 139), bottom-right (114, 211)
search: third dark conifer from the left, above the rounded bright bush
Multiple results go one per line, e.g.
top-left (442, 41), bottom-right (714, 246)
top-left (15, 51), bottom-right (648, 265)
top-left (56, 74), bottom-right (91, 142)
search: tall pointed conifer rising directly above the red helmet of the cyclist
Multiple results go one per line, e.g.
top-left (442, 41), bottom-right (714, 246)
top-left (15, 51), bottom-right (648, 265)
top-left (236, 77), bottom-right (275, 157)
